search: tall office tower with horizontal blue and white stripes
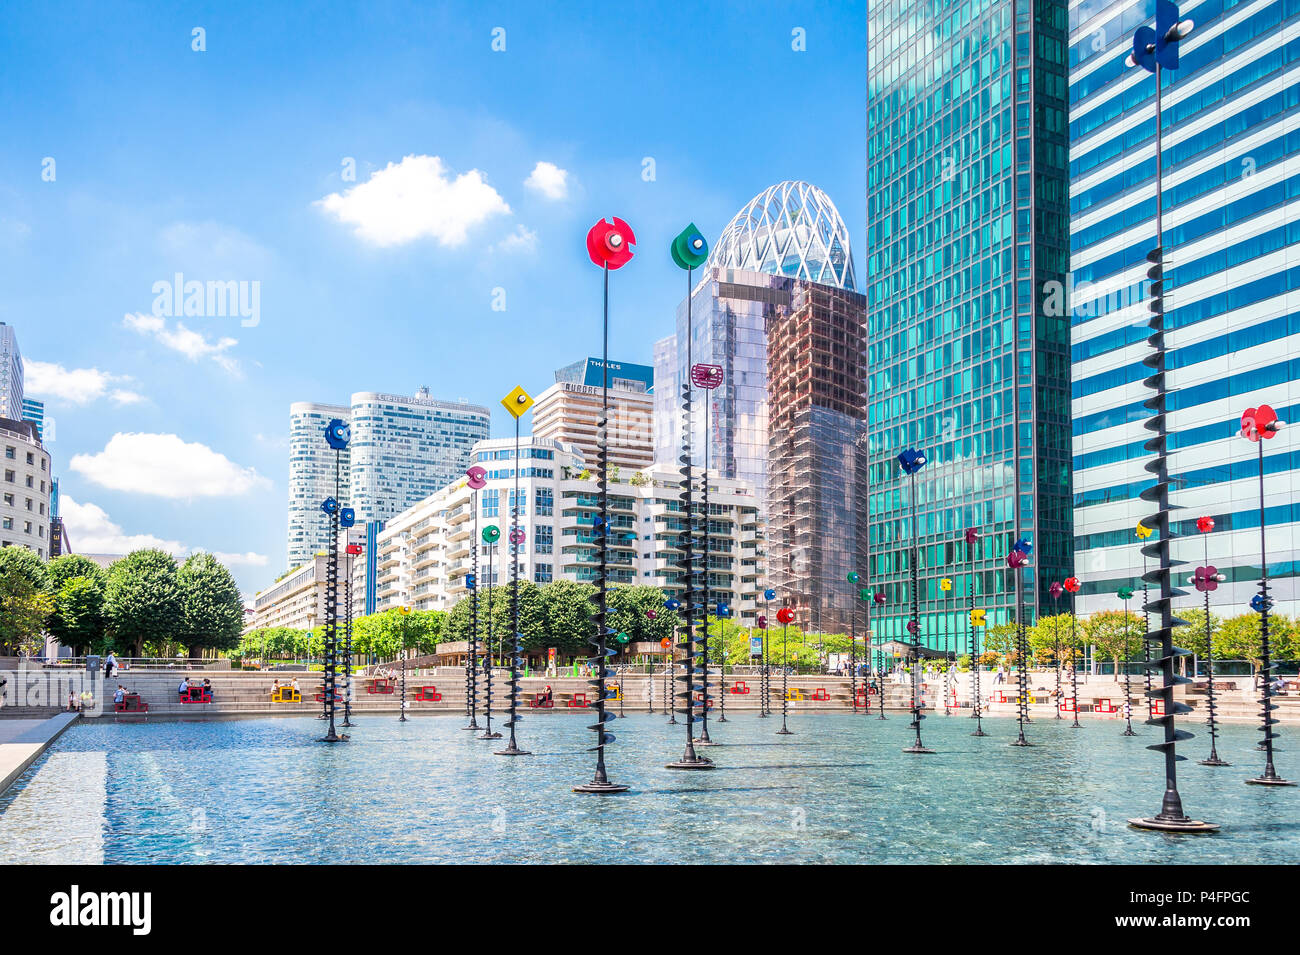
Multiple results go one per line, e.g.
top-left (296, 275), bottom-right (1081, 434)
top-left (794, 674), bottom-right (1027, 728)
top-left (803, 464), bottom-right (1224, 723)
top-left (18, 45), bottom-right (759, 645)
top-left (1070, 0), bottom-right (1300, 616)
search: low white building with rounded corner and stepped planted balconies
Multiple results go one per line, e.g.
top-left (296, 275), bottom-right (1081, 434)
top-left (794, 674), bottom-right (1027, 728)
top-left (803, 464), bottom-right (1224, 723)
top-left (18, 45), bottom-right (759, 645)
top-left (377, 438), bottom-right (767, 622)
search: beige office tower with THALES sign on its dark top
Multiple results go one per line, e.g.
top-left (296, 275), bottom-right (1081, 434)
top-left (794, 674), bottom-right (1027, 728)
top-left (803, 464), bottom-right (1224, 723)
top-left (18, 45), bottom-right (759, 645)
top-left (533, 359), bottom-right (654, 469)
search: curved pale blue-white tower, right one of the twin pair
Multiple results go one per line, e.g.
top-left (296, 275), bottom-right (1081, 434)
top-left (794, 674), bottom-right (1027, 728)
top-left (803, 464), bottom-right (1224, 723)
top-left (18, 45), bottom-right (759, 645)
top-left (348, 387), bottom-right (491, 524)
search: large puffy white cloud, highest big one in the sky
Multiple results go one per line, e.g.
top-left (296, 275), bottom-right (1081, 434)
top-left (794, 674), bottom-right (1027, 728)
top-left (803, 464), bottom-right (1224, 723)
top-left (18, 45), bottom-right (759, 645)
top-left (316, 156), bottom-right (510, 247)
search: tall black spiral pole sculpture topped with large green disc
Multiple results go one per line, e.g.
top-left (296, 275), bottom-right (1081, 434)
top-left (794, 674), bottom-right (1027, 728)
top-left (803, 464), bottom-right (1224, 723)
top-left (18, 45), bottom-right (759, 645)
top-left (668, 223), bottom-right (714, 769)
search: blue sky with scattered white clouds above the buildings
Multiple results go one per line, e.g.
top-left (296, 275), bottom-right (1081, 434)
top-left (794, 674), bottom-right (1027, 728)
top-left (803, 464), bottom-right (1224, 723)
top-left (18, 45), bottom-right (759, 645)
top-left (0, 0), bottom-right (866, 592)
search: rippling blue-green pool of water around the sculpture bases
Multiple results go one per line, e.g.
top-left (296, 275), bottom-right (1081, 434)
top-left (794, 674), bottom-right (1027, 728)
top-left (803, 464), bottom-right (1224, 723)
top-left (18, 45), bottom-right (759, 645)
top-left (0, 713), bottom-right (1300, 863)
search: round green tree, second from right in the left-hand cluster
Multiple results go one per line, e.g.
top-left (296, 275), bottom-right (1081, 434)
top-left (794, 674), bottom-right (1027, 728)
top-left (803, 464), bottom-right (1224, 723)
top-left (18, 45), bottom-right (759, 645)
top-left (104, 550), bottom-right (185, 656)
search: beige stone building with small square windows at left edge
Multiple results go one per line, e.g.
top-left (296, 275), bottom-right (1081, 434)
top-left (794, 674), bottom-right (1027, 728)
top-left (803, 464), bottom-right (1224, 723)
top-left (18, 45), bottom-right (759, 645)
top-left (0, 416), bottom-right (53, 560)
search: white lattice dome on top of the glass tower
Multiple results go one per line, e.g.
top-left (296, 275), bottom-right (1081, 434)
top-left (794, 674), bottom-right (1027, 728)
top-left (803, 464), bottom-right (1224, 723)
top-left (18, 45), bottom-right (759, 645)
top-left (709, 179), bottom-right (857, 291)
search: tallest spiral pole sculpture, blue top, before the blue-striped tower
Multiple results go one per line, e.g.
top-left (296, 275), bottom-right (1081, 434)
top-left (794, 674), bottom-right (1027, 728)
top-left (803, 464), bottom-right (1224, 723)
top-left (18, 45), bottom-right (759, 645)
top-left (1126, 0), bottom-right (1218, 833)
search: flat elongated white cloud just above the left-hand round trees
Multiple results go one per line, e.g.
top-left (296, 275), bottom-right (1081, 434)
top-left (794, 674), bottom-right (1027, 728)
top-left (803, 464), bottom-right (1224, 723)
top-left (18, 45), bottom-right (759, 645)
top-left (70, 433), bottom-right (270, 500)
